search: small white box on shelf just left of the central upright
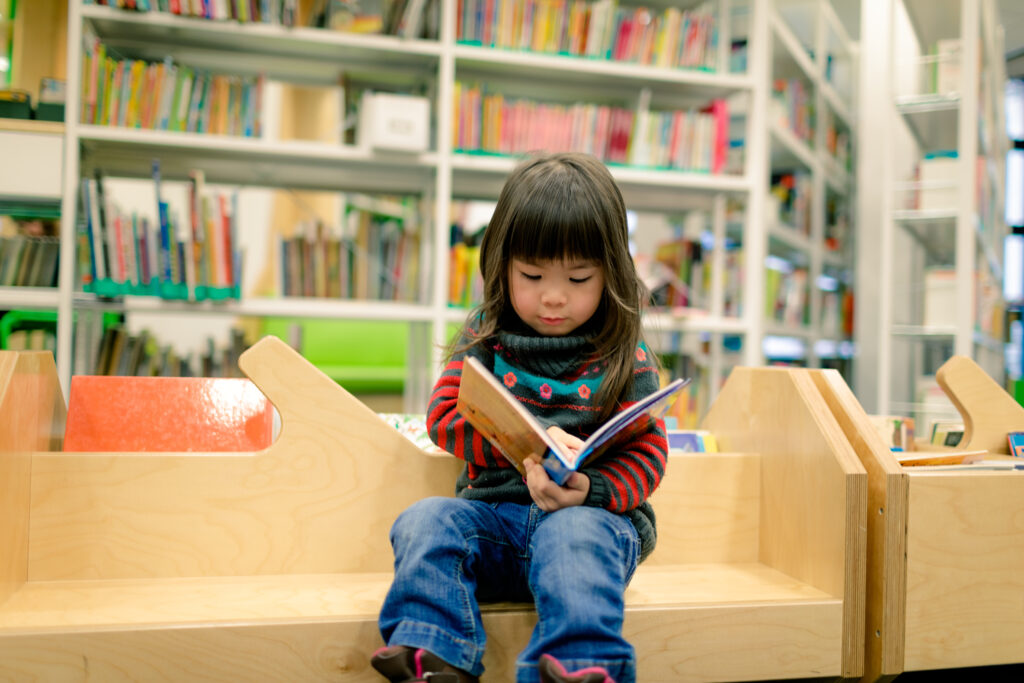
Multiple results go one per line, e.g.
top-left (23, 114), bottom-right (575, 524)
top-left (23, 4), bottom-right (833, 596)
top-left (358, 91), bottom-right (430, 152)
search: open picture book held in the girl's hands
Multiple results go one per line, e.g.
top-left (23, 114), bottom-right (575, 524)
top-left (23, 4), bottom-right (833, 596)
top-left (457, 357), bottom-right (689, 485)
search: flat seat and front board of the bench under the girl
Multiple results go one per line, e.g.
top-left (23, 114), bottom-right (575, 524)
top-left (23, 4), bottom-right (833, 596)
top-left (0, 564), bottom-right (842, 683)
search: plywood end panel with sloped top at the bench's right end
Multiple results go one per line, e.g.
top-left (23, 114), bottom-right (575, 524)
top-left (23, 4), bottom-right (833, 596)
top-left (702, 368), bottom-right (867, 676)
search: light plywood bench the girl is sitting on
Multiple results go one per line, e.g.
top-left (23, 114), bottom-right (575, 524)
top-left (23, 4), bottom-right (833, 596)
top-left (0, 337), bottom-right (867, 683)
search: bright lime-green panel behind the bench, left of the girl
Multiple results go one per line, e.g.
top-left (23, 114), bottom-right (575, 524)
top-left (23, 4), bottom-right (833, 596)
top-left (256, 317), bottom-right (411, 394)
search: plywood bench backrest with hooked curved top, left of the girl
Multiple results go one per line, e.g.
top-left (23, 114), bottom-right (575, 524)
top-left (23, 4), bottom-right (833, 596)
top-left (29, 337), bottom-right (461, 581)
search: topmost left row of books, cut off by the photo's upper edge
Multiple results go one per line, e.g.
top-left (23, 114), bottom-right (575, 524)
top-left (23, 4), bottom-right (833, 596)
top-left (86, 0), bottom-right (440, 39)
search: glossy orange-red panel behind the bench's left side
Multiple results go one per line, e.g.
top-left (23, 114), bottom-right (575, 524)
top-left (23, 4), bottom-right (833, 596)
top-left (63, 375), bottom-right (273, 453)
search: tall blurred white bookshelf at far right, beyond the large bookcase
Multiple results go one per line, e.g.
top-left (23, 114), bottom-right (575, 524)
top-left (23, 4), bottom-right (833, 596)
top-left (857, 0), bottom-right (1008, 430)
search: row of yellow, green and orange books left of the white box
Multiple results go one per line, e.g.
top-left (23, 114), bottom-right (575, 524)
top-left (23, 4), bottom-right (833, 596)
top-left (80, 29), bottom-right (264, 137)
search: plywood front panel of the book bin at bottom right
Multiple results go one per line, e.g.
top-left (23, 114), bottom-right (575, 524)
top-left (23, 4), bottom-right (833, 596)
top-left (905, 471), bottom-right (1024, 670)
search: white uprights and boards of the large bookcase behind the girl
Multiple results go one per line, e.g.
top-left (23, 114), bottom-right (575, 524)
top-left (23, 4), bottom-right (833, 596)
top-left (51, 0), bottom-right (855, 405)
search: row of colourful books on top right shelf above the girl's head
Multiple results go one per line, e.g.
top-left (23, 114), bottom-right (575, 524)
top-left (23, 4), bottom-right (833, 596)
top-left (456, 0), bottom-right (718, 70)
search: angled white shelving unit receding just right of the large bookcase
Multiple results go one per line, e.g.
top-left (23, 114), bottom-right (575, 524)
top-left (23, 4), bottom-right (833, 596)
top-left (765, 0), bottom-right (859, 370)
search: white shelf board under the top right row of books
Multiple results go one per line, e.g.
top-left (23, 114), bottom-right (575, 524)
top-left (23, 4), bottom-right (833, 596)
top-left (455, 45), bottom-right (754, 99)
